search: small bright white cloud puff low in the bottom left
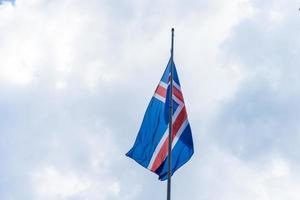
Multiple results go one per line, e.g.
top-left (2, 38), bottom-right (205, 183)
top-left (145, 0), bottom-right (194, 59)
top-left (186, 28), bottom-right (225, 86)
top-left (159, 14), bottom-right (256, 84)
top-left (31, 166), bottom-right (120, 200)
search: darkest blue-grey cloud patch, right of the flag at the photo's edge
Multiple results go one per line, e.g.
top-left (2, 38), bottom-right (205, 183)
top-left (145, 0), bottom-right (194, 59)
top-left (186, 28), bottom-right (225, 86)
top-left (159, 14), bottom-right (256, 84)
top-left (214, 79), bottom-right (300, 160)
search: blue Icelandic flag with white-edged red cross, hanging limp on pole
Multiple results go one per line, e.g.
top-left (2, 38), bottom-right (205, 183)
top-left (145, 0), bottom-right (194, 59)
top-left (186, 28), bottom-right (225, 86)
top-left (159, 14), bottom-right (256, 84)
top-left (126, 59), bottom-right (194, 181)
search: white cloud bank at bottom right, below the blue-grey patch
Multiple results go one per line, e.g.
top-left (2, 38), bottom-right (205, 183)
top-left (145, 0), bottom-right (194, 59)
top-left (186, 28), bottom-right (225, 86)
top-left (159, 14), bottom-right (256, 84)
top-left (183, 146), bottom-right (300, 200)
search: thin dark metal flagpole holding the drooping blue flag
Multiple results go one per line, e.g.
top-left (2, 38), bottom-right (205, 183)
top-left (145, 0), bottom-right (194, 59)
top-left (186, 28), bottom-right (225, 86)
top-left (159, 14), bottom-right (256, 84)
top-left (167, 28), bottom-right (174, 200)
